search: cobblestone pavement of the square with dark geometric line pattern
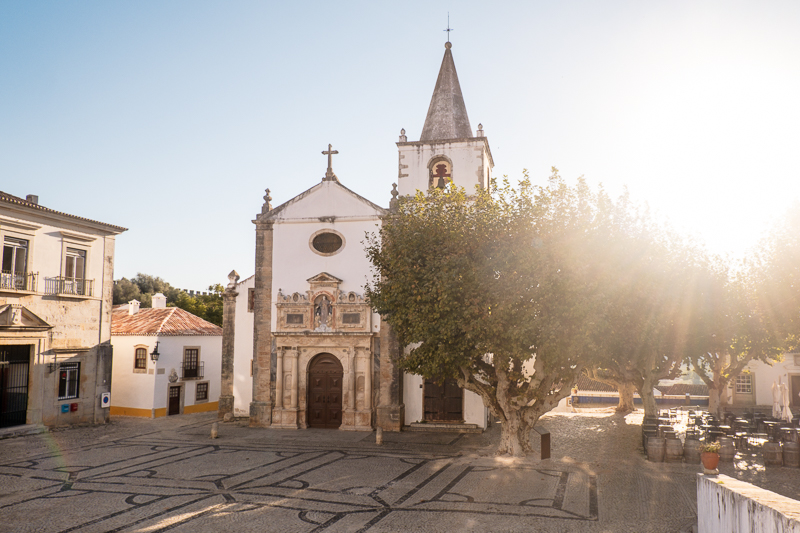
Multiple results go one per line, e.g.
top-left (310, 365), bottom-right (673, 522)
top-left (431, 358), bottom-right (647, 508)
top-left (0, 409), bottom-right (800, 533)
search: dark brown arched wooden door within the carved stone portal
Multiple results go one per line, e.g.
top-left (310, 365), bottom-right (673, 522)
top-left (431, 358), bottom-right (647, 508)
top-left (307, 353), bottom-right (344, 429)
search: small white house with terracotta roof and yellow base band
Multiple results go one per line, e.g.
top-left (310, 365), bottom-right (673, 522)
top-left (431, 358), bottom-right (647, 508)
top-left (111, 293), bottom-right (222, 418)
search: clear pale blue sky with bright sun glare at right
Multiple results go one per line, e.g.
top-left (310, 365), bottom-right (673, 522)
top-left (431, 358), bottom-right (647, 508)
top-left (0, 0), bottom-right (800, 290)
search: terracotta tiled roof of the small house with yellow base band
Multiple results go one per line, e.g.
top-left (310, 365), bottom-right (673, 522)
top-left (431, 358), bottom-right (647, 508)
top-left (111, 307), bottom-right (222, 335)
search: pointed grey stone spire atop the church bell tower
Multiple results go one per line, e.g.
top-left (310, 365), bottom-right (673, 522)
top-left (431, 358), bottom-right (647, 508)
top-left (419, 42), bottom-right (472, 141)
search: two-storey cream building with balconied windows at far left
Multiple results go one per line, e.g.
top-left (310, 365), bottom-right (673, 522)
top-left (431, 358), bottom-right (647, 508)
top-left (0, 192), bottom-right (125, 428)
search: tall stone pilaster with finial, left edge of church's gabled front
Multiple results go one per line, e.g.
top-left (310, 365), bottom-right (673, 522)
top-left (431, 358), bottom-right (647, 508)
top-left (250, 214), bottom-right (273, 427)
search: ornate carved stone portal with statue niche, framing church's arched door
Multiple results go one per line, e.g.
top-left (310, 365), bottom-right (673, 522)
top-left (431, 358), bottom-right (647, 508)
top-left (272, 272), bottom-right (375, 431)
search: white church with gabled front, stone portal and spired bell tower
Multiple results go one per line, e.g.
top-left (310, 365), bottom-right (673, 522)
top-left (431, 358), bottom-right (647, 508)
top-left (219, 42), bottom-right (493, 431)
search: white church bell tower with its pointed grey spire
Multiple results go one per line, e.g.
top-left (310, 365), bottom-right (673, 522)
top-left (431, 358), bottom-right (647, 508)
top-left (397, 41), bottom-right (494, 195)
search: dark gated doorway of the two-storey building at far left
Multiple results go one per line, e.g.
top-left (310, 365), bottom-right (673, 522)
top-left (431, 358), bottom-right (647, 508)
top-left (0, 344), bottom-right (31, 428)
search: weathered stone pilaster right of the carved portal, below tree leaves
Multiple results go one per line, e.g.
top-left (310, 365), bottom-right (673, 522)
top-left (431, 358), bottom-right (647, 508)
top-left (377, 320), bottom-right (406, 431)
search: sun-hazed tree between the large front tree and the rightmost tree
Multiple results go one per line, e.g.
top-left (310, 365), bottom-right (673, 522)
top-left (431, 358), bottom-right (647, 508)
top-left (586, 194), bottom-right (694, 415)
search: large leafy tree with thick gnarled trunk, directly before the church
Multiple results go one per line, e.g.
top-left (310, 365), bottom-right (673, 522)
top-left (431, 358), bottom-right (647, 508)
top-left (366, 169), bottom-right (603, 455)
